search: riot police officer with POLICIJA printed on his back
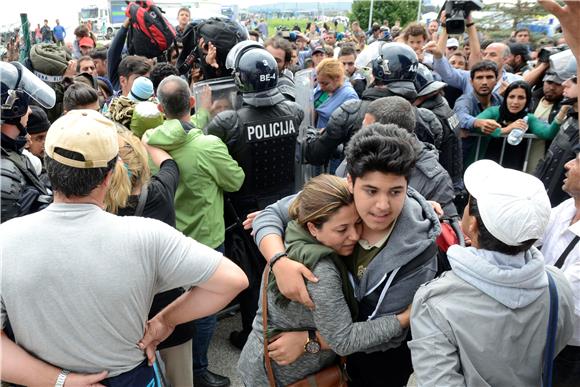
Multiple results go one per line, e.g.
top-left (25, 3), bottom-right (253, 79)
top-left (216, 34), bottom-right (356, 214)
top-left (206, 41), bottom-right (304, 348)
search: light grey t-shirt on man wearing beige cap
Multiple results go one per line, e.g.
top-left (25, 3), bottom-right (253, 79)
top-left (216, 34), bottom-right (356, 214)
top-left (0, 204), bottom-right (222, 377)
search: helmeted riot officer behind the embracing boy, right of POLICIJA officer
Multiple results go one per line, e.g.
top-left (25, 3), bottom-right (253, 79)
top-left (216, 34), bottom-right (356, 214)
top-left (302, 43), bottom-right (442, 165)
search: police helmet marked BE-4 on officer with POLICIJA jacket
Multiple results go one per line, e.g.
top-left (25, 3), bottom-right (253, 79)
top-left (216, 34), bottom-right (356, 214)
top-left (226, 41), bottom-right (278, 93)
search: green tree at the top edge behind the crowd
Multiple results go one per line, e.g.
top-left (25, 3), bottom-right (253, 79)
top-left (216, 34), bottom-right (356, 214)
top-left (349, 0), bottom-right (419, 30)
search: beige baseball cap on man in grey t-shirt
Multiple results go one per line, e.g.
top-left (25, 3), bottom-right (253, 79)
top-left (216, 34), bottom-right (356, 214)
top-left (44, 109), bottom-right (119, 168)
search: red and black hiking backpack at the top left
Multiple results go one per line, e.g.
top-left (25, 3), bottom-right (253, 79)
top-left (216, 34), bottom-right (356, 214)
top-left (125, 0), bottom-right (175, 58)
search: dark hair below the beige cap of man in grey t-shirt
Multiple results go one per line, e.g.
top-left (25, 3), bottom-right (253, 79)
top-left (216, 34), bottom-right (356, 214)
top-left (44, 148), bottom-right (117, 198)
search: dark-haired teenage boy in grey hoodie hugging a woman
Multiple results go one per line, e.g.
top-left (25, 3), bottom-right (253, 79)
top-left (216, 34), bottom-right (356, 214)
top-left (254, 124), bottom-right (440, 386)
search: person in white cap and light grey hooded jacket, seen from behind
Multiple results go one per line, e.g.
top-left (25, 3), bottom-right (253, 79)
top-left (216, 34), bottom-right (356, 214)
top-left (409, 160), bottom-right (574, 386)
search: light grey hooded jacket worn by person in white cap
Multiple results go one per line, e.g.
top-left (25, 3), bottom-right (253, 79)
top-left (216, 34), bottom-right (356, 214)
top-left (409, 246), bottom-right (574, 387)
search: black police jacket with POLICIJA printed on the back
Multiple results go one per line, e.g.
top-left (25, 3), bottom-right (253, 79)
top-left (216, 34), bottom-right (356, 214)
top-left (207, 95), bottom-right (304, 214)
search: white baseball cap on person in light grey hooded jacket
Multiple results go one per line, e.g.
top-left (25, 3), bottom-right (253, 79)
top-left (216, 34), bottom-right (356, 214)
top-left (464, 160), bottom-right (551, 246)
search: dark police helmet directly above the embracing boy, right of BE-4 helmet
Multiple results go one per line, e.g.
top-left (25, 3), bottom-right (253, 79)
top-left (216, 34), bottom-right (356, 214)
top-left (372, 43), bottom-right (419, 83)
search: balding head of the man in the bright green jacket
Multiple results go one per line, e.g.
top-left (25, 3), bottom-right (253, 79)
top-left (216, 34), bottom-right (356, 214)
top-left (157, 75), bottom-right (194, 119)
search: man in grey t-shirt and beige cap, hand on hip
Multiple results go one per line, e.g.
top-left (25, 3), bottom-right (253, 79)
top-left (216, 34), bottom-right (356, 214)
top-left (0, 110), bottom-right (247, 386)
